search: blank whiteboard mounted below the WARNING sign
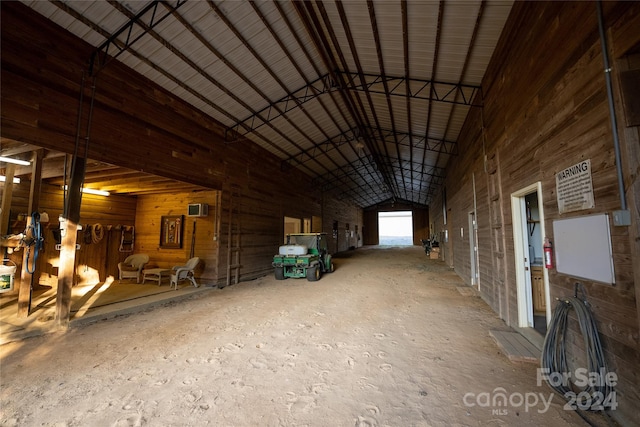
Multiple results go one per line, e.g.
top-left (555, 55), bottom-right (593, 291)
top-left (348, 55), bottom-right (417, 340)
top-left (553, 214), bottom-right (615, 284)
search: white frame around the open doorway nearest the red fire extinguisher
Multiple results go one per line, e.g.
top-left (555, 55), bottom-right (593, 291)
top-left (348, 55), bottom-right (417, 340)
top-left (511, 181), bottom-right (551, 328)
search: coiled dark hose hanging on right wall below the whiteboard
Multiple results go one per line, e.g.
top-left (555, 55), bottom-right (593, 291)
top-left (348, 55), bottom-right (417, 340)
top-left (541, 284), bottom-right (617, 411)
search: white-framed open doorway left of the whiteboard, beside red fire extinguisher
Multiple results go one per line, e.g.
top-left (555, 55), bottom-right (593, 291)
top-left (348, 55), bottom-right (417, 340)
top-left (511, 182), bottom-right (551, 335)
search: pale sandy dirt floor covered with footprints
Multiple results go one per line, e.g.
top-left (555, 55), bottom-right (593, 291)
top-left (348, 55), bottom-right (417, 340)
top-left (0, 247), bottom-right (584, 426)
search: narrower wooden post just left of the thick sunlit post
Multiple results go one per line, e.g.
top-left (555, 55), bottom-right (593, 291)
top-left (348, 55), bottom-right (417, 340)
top-left (18, 150), bottom-right (44, 318)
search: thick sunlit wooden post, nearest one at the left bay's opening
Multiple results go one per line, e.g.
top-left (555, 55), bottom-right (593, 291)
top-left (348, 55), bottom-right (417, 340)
top-left (56, 157), bottom-right (87, 328)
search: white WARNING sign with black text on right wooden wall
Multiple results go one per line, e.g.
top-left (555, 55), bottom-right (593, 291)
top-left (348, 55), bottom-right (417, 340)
top-left (556, 159), bottom-right (595, 214)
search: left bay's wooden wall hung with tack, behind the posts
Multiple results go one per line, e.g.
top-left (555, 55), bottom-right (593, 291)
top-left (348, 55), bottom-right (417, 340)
top-left (0, 180), bottom-right (136, 292)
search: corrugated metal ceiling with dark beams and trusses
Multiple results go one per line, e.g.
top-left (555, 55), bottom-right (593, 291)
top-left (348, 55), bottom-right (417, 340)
top-left (18, 0), bottom-right (512, 207)
